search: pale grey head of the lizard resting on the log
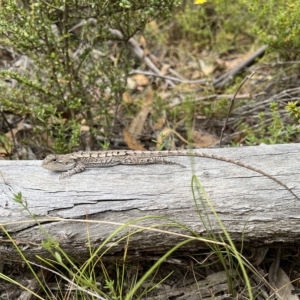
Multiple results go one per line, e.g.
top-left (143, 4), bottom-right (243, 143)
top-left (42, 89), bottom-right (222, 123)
top-left (42, 154), bottom-right (76, 171)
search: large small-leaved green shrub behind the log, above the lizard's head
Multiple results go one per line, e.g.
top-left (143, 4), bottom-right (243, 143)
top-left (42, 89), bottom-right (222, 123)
top-left (0, 0), bottom-right (178, 153)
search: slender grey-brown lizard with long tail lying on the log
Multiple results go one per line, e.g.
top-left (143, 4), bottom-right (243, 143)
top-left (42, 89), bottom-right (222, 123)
top-left (42, 150), bottom-right (300, 201)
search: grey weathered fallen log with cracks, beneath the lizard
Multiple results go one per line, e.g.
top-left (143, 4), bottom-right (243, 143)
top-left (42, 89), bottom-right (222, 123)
top-left (0, 144), bottom-right (300, 261)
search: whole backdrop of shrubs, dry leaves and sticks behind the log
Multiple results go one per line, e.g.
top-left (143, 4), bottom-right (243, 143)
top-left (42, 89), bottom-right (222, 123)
top-left (0, 0), bottom-right (300, 159)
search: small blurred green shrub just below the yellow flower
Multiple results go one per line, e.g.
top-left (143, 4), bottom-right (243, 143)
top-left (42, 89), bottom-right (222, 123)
top-left (176, 0), bottom-right (253, 51)
